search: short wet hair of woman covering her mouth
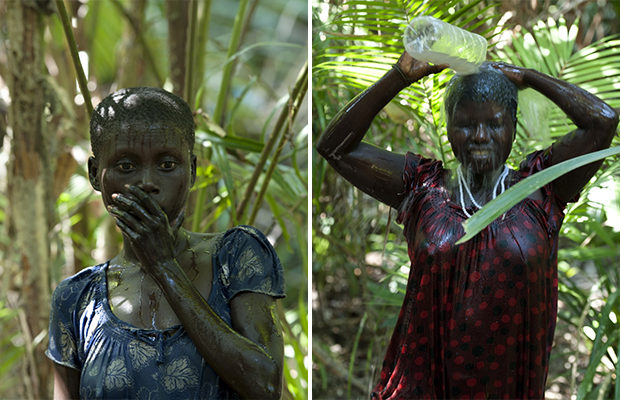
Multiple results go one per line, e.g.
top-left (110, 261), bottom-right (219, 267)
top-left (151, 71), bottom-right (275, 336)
top-left (90, 87), bottom-right (195, 157)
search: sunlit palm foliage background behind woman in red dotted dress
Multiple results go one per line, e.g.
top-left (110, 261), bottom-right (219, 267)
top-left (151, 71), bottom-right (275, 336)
top-left (312, 0), bottom-right (620, 399)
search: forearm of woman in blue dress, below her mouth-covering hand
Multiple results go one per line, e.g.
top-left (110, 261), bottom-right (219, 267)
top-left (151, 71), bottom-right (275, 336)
top-left (154, 261), bottom-right (281, 399)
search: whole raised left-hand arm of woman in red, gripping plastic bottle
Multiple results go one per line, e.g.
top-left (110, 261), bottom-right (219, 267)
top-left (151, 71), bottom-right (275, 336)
top-left (317, 53), bottom-right (445, 208)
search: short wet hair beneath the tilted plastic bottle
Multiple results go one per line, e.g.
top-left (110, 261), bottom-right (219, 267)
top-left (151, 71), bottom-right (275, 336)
top-left (444, 63), bottom-right (519, 128)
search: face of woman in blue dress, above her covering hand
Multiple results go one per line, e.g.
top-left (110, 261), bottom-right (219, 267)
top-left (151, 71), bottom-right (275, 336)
top-left (89, 125), bottom-right (196, 222)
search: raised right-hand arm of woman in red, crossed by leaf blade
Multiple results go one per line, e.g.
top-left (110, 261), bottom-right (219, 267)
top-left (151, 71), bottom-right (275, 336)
top-left (495, 63), bottom-right (618, 202)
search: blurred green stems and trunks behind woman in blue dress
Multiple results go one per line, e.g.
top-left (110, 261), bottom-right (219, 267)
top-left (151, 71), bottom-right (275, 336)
top-left (0, 0), bottom-right (309, 399)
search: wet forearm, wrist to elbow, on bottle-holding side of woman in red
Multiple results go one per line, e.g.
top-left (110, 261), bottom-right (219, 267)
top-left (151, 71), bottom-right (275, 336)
top-left (317, 68), bottom-right (408, 161)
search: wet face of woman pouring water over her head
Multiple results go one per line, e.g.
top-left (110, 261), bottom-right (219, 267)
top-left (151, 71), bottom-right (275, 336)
top-left (448, 101), bottom-right (515, 174)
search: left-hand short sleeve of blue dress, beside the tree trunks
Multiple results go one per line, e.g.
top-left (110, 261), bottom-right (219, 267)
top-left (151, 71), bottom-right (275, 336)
top-left (45, 278), bottom-right (81, 370)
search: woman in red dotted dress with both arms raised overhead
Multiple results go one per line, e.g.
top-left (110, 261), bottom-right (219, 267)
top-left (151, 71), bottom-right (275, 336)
top-left (317, 53), bottom-right (618, 399)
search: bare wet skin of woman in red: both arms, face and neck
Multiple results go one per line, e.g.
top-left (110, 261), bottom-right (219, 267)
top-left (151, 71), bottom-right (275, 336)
top-left (317, 53), bottom-right (618, 208)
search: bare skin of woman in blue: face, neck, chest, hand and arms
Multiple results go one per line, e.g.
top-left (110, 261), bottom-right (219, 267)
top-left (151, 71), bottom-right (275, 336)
top-left (55, 126), bottom-right (283, 398)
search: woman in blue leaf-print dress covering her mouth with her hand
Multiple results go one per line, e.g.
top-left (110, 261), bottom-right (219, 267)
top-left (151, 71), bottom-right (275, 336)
top-left (47, 88), bottom-right (284, 399)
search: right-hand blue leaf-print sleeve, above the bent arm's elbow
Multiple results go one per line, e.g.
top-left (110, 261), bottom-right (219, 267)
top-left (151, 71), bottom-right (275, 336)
top-left (217, 225), bottom-right (285, 301)
